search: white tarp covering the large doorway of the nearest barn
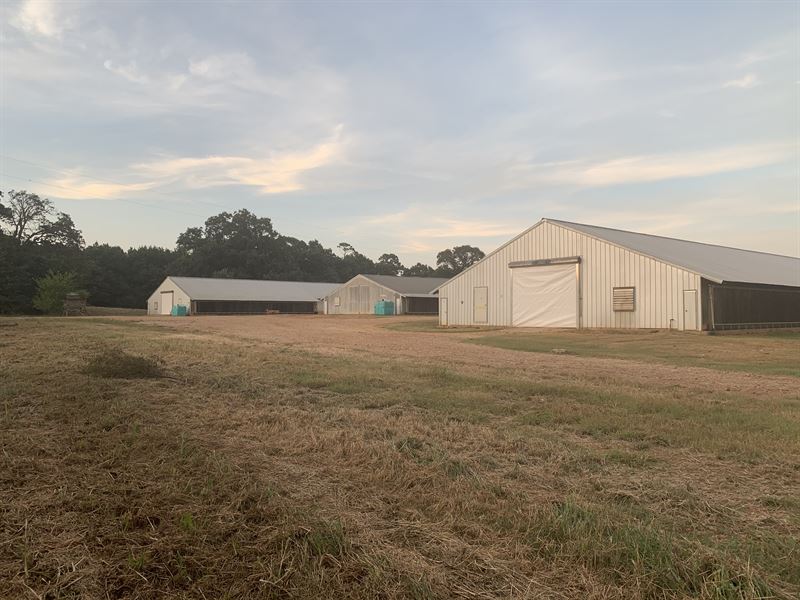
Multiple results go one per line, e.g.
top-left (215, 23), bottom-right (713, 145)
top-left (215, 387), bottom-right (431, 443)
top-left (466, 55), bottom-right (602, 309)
top-left (511, 263), bottom-right (578, 327)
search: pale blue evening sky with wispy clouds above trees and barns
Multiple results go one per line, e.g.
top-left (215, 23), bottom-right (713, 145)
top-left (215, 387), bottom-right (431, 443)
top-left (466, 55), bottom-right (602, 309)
top-left (0, 0), bottom-right (800, 264)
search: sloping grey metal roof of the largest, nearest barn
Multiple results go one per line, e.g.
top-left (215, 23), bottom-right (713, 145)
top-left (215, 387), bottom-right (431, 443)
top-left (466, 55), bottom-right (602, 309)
top-left (542, 219), bottom-right (800, 287)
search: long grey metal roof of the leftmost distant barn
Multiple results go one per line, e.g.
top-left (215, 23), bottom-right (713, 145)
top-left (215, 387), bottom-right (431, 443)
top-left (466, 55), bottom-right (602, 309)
top-left (169, 277), bottom-right (340, 302)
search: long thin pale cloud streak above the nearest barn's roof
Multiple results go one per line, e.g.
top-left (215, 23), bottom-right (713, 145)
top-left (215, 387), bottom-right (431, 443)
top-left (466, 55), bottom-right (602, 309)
top-left (511, 143), bottom-right (795, 187)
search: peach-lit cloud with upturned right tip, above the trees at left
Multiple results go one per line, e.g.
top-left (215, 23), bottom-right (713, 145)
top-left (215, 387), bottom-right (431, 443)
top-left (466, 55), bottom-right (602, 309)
top-left (134, 126), bottom-right (344, 194)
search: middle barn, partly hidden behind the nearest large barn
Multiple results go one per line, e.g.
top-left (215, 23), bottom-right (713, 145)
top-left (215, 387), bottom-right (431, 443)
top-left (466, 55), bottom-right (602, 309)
top-left (325, 275), bottom-right (447, 315)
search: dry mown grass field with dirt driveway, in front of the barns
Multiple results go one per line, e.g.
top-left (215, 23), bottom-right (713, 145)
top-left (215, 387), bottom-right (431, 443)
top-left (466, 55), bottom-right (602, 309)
top-left (0, 317), bottom-right (800, 600)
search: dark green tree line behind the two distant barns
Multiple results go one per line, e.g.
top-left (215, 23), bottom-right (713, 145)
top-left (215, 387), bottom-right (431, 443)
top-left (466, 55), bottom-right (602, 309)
top-left (0, 190), bottom-right (484, 313)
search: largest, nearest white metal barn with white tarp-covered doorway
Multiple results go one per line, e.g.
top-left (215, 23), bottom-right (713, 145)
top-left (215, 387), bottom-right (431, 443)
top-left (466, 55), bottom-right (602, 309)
top-left (437, 219), bottom-right (800, 330)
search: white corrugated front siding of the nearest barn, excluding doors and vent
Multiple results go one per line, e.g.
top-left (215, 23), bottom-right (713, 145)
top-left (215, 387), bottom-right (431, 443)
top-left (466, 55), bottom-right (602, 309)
top-left (439, 221), bottom-right (702, 329)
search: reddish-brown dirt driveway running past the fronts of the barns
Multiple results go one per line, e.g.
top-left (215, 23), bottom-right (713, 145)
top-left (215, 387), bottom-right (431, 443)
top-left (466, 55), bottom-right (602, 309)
top-left (143, 315), bottom-right (800, 396)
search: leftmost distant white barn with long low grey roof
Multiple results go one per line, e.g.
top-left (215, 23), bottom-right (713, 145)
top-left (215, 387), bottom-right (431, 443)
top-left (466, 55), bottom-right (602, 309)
top-left (147, 276), bottom-right (340, 315)
